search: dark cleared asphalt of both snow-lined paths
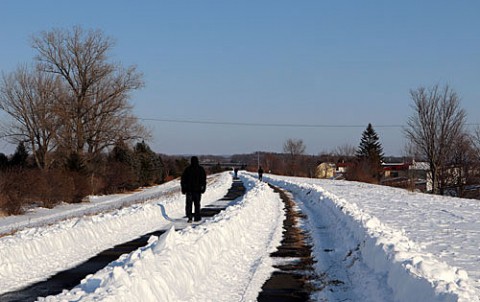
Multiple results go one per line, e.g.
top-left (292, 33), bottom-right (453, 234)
top-left (0, 179), bottom-right (315, 302)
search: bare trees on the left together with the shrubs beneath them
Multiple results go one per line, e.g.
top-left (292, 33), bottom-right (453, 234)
top-left (0, 27), bottom-right (158, 213)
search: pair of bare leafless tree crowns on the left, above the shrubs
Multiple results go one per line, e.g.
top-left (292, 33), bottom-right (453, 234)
top-left (0, 27), bottom-right (148, 170)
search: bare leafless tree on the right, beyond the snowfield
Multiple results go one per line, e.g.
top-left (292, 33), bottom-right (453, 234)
top-left (404, 85), bottom-right (466, 194)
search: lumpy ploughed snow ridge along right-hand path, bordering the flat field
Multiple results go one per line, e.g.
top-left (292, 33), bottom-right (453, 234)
top-left (268, 176), bottom-right (479, 302)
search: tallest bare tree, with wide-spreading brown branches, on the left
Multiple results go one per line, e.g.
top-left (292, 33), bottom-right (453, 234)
top-left (32, 27), bottom-right (147, 163)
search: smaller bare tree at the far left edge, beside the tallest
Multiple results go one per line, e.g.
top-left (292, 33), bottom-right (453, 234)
top-left (0, 66), bottom-right (60, 169)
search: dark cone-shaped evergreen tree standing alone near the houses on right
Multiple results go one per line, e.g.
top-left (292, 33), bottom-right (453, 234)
top-left (356, 123), bottom-right (384, 179)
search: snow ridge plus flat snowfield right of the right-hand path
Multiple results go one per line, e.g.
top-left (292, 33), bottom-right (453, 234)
top-left (264, 176), bottom-right (480, 302)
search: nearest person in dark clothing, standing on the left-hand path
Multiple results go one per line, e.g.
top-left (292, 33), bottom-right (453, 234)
top-left (181, 156), bottom-right (207, 222)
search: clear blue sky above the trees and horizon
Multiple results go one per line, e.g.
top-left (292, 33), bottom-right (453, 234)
top-left (0, 0), bottom-right (480, 155)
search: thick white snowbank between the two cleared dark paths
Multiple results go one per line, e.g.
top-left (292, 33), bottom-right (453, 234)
top-left (41, 173), bottom-right (285, 302)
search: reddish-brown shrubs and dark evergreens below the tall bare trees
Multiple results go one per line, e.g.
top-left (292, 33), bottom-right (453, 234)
top-left (0, 142), bottom-right (169, 214)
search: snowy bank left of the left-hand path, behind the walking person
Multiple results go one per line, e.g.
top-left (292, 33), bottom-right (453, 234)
top-left (0, 173), bottom-right (232, 293)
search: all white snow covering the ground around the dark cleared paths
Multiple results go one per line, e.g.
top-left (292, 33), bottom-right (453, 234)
top-left (0, 173), bottom-right (480, 302)
